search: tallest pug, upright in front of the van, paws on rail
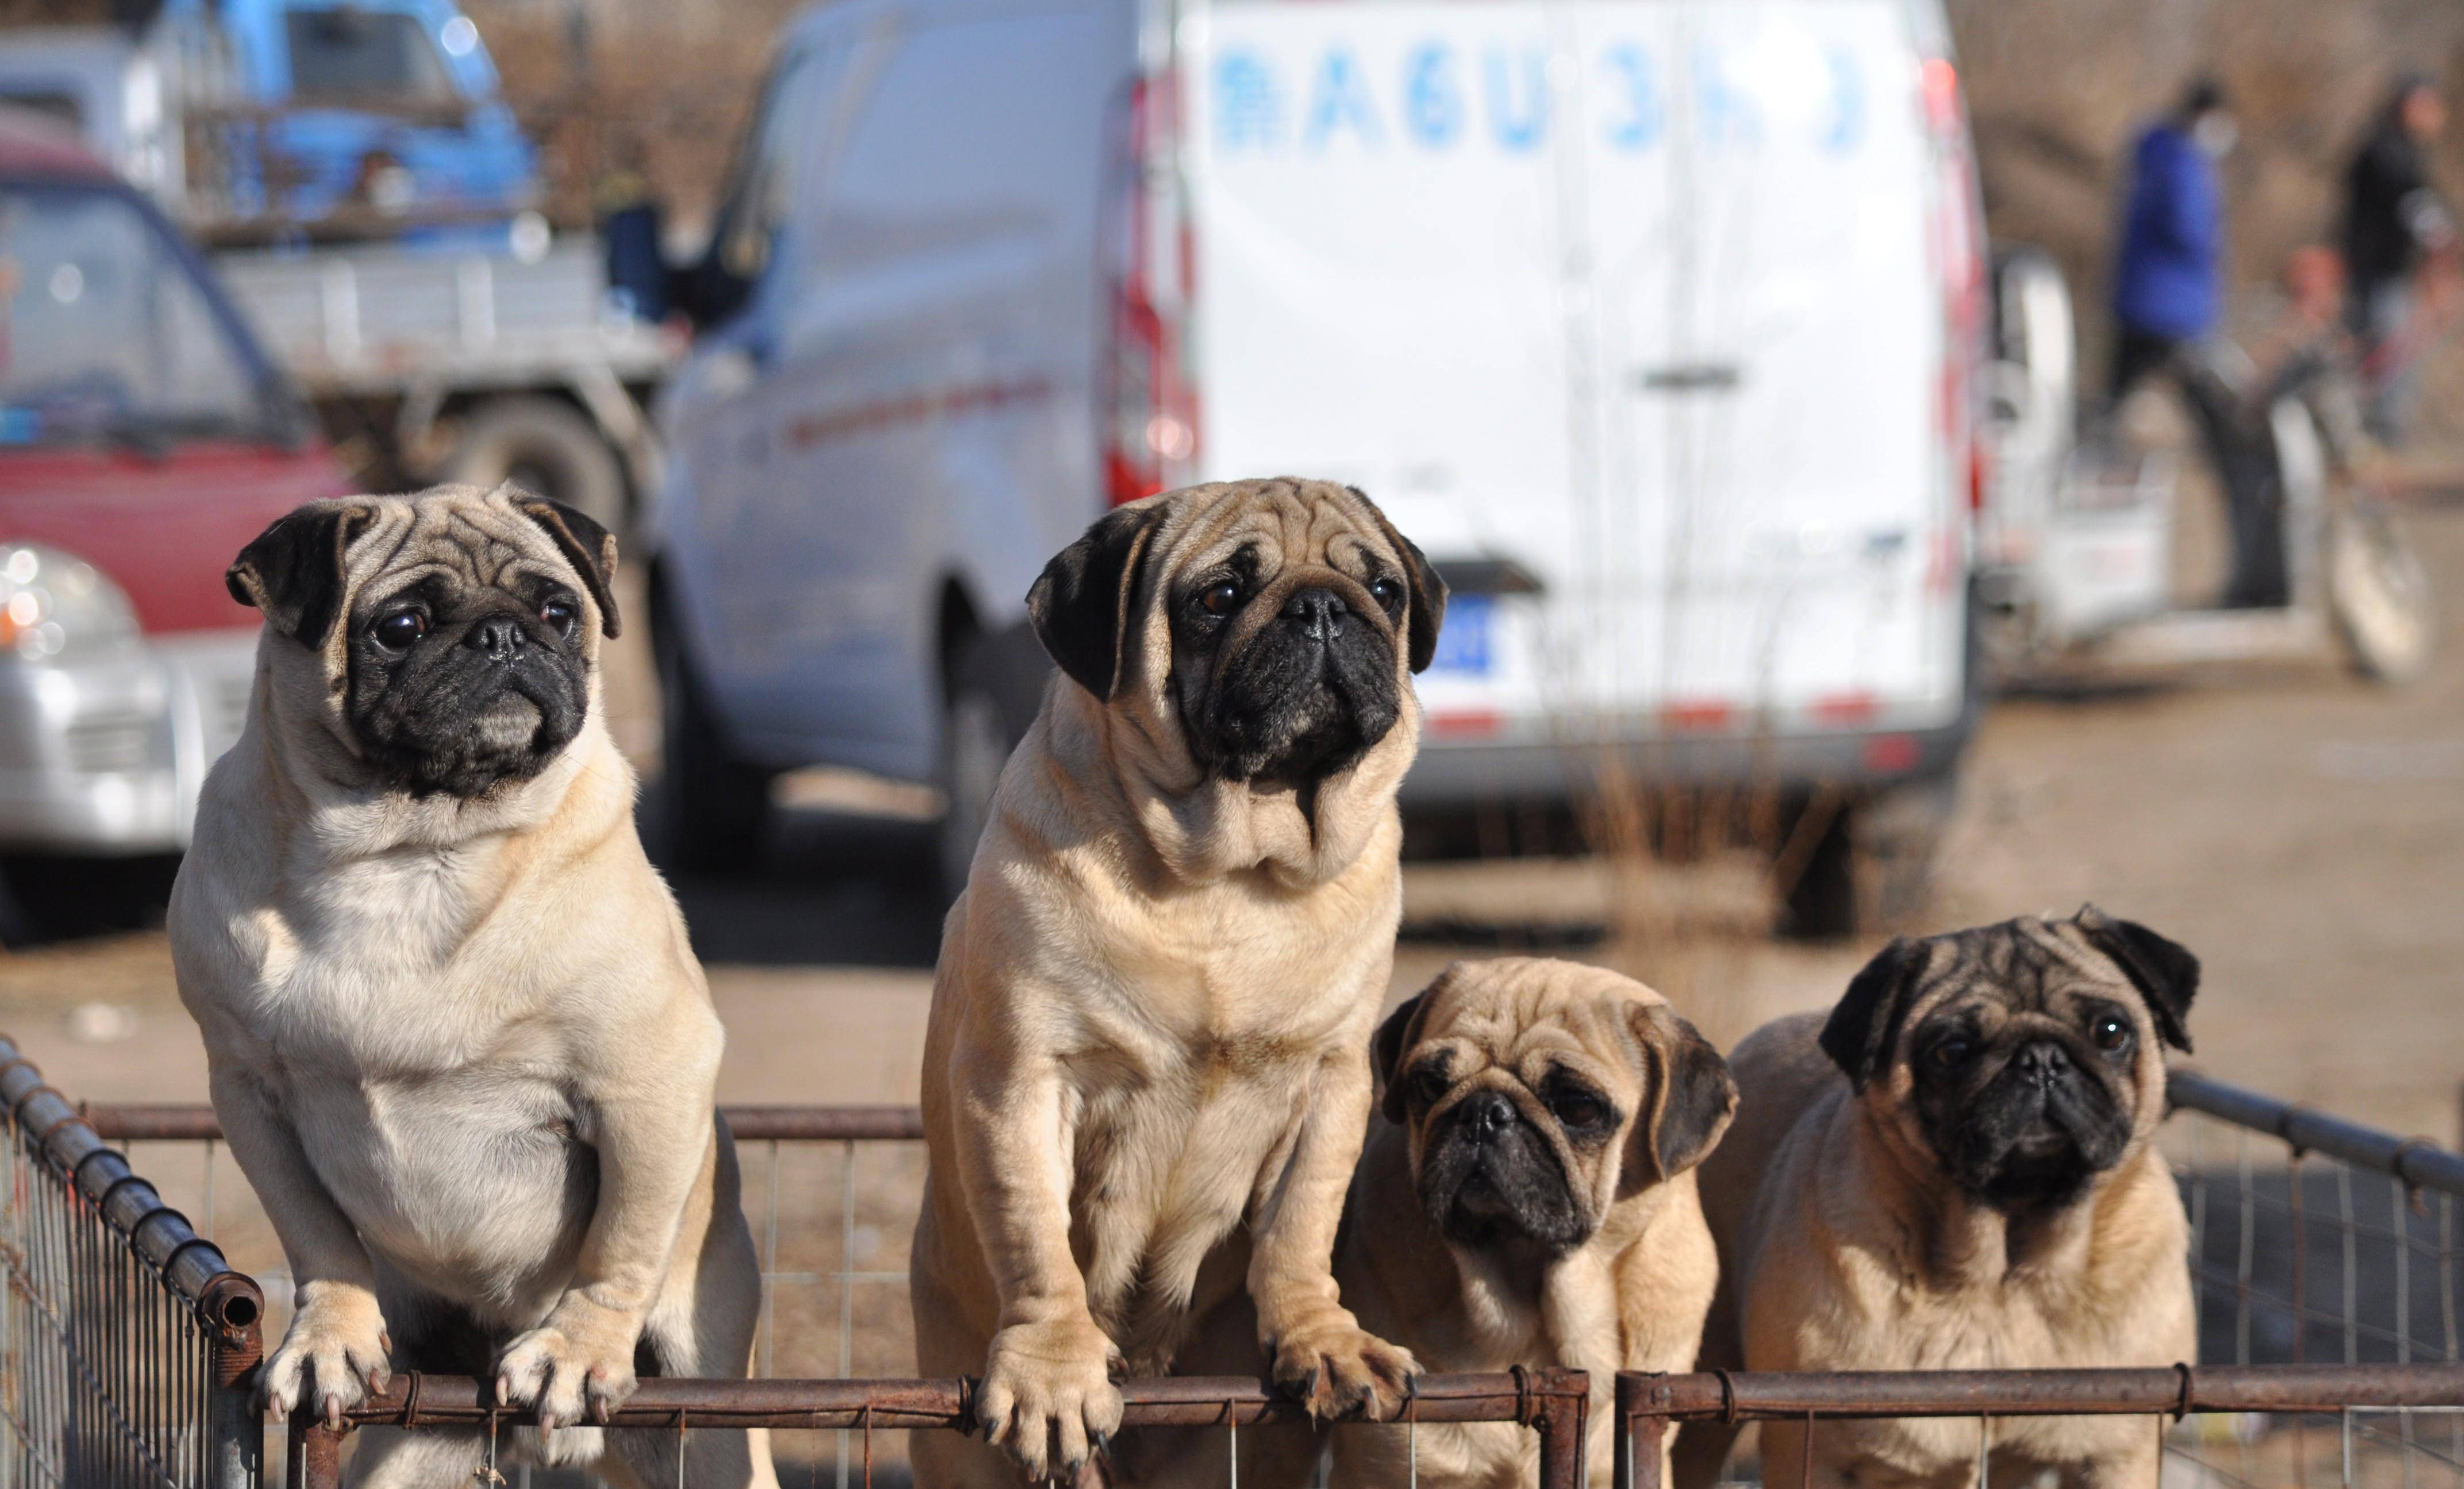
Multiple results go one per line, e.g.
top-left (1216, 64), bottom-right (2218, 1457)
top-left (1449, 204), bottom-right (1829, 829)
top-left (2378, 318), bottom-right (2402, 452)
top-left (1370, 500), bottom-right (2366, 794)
top-left (912, 478), bottom-right (1446, 1487)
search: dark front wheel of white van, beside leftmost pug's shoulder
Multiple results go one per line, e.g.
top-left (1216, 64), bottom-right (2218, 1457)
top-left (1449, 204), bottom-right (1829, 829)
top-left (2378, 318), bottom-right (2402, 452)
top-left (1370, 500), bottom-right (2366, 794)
top-left (650, 589), bottom-right (771, 873)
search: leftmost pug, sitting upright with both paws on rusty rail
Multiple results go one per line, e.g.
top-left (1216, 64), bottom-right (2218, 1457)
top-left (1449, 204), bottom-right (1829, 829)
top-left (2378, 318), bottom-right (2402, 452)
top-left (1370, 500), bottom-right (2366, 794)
top-left (170, 486), bottom-right (773, 1487)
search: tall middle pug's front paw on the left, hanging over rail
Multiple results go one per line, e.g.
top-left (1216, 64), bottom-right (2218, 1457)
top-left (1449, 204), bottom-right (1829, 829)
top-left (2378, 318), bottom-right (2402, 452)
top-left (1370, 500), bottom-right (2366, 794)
top-left (976, 1317), bottom-right (1121, 1482)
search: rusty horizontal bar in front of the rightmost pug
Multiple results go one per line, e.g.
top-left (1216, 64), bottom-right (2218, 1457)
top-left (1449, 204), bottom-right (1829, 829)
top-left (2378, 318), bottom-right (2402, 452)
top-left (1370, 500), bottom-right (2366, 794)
top-left (1616, 1363), bottom-right (2464, 1422)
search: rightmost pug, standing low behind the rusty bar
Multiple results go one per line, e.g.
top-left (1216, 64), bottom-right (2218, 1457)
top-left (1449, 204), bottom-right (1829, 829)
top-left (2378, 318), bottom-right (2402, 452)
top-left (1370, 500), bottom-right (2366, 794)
top-left (1676, 905), bottom-right (2198, 1489)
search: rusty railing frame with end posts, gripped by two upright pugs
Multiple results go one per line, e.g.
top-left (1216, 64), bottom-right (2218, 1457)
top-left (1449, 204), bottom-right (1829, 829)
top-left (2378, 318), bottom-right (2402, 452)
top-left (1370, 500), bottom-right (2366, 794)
top-left (288, 1371), bottom-right (1592, 1489)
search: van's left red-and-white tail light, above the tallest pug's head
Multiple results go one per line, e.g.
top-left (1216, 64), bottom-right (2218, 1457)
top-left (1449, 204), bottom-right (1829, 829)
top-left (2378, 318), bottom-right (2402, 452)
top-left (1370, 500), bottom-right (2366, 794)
top-left (1104, 69), bottom-right (1198, 505)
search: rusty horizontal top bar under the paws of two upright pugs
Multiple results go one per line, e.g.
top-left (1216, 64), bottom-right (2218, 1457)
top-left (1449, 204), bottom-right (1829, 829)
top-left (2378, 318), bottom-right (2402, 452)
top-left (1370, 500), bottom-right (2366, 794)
top-left (345, 1371), bottom-right (1589, 1428)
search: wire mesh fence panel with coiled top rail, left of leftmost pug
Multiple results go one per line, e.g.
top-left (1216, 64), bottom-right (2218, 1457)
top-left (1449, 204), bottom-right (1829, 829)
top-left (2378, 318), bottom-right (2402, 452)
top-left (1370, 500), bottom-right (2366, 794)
top-left (0, 1038), bottom-right (264, 1489)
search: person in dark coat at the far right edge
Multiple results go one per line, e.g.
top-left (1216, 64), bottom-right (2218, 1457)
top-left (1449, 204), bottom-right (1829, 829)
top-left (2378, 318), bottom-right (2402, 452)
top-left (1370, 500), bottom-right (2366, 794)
top-left (2341, 74), bottom-right (2457, 444)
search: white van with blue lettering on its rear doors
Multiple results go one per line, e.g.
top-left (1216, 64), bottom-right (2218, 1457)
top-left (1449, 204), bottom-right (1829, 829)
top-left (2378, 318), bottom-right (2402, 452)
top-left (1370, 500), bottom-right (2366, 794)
top-left (656, 0), bottom-right (1984, 922)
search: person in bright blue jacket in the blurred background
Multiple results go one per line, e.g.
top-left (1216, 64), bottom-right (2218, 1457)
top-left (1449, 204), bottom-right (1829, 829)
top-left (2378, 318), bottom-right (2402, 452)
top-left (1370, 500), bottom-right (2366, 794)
top-left (2107, 76), bottom-right (2235, 405)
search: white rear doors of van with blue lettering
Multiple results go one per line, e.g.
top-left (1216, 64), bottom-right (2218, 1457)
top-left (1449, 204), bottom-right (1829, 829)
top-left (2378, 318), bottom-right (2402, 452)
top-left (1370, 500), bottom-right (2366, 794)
top-left (1183, 0), bottom-right (1964, 769)
